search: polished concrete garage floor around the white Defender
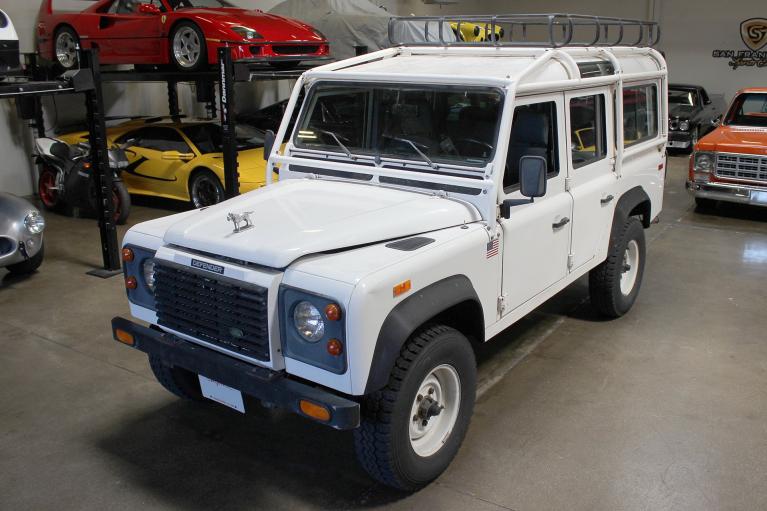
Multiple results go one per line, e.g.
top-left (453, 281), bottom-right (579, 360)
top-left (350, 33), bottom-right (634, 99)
top-left (0, 158), bottom-right (767, 511)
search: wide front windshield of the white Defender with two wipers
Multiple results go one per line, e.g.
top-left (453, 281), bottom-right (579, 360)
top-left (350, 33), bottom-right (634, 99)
top-left (294, 84), bottom-right (503, 168)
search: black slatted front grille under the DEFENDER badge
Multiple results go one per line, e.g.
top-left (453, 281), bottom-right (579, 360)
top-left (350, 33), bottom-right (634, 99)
top-left (155, 262), bottom-right (269, 362)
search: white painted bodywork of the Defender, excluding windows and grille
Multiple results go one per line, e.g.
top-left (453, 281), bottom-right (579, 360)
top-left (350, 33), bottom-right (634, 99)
top-left (125, 43), bottom-right (667, 395)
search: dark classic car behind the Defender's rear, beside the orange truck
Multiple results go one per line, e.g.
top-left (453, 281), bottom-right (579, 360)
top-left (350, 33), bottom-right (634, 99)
top-left (668, 84), bottom-right (725, 151)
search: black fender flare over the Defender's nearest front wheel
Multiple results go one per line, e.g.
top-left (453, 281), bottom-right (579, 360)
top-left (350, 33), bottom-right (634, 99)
top-left (365, 275), bottom-right (484, 394)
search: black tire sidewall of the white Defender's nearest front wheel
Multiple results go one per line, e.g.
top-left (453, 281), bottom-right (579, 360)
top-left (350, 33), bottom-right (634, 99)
top-left (392, 330), bottom-right (476, 488)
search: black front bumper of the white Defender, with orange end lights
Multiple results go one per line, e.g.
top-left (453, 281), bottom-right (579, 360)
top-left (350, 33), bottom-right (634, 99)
top-left (112, 317), bottom-right (360, 430)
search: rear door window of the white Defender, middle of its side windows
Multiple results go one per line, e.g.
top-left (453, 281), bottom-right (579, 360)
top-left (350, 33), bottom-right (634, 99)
top-left (570, 94), bottom-right (607, 169)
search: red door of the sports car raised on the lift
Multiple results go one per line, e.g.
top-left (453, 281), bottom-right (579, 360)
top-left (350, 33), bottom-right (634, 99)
top-left (93, 0), bottom-right (165, 64)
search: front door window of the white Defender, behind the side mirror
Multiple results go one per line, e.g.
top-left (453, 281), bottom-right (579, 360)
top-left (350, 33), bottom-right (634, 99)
top-left (503, 101), bottom-right (559, 193)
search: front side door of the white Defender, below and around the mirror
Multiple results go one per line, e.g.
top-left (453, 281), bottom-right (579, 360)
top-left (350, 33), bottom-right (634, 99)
top-left (500, 93), bottom-right (573, 314)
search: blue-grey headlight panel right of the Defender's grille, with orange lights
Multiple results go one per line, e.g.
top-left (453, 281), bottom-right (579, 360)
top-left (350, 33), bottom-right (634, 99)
top-left (279, 284), bottom-right (346, 374)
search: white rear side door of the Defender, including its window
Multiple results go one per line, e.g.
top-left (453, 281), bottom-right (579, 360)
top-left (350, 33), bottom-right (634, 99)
top-left (565, 88), bottom-right (617, 271)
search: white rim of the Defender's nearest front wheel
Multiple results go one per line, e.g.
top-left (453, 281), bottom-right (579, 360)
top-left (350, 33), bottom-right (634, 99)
top-left (409, 364), bottom-right (461, 458)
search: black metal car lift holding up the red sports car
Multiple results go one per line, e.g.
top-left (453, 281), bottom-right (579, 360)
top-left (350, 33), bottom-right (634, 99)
top-left (12, 48), bottom-right (325, 278)
